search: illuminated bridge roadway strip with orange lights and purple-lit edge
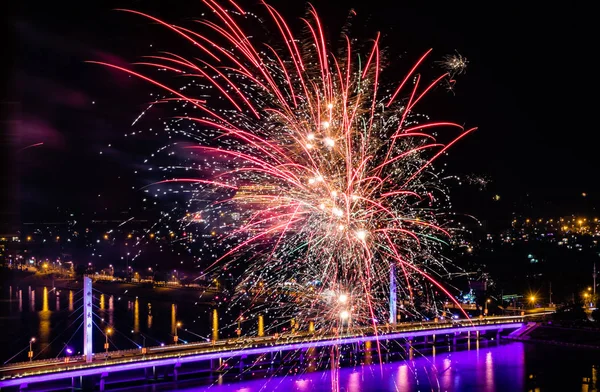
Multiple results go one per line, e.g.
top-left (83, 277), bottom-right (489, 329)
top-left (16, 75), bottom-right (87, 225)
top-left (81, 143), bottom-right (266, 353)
top-left (0, 312), bottom-right (550, 388)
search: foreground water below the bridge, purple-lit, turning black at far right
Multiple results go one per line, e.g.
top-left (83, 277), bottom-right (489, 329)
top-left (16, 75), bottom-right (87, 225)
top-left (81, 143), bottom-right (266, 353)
top-left (163, 342), bottom-right (600, 392)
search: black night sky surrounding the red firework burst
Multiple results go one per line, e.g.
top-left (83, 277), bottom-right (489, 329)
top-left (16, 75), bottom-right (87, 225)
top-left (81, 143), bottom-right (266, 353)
top-left (0, 0), bottom-right (600, 228)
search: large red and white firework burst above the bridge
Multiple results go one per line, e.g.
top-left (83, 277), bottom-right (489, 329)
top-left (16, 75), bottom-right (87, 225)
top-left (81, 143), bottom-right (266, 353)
top-left (92, 0), bottom-right (475, 333)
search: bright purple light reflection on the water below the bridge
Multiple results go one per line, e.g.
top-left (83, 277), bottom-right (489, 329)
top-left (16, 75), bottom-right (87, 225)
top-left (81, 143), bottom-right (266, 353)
top-left (178, 343), bottom-right (526, 392)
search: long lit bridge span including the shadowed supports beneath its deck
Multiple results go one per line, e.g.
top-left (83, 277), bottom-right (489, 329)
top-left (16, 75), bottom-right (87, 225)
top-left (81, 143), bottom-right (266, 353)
top-left (0, 314), bottom-right (541, 391)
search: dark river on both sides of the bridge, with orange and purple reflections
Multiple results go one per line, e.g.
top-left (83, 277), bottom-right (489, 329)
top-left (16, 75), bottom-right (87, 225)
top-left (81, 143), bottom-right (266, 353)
top-left (0, 285), bottom-right (600, 392)
